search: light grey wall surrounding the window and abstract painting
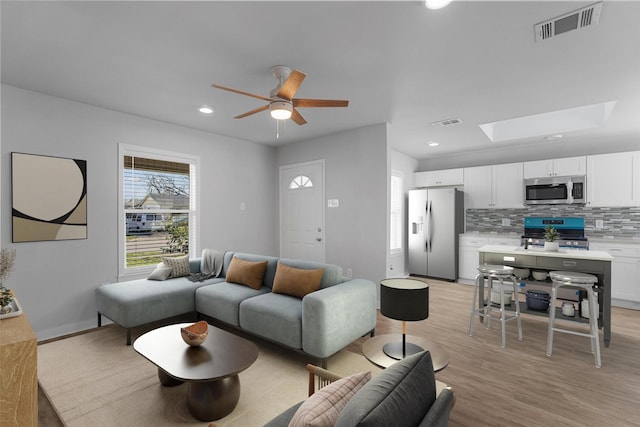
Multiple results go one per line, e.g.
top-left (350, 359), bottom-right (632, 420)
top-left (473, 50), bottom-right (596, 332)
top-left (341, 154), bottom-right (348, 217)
top-left (0, 85), bottom-right (278, 339)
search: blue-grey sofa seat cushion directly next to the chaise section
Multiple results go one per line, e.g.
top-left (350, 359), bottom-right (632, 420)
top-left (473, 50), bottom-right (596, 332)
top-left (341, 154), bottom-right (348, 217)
top-left (195, 282), bottom-right (270, 326)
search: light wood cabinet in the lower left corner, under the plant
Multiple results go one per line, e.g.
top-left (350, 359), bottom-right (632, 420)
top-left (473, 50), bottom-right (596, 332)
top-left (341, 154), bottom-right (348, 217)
top-left (0, 300), bottom-right (38, 427)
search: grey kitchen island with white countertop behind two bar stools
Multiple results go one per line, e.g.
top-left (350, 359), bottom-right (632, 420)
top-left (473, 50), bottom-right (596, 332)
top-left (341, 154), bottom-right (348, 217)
top-left (479, 245), bottom-right (613, 347)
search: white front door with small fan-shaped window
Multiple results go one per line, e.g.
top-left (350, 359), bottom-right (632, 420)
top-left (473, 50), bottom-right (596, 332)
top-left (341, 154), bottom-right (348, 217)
top-left (280, 160), bottom-right (324, 262)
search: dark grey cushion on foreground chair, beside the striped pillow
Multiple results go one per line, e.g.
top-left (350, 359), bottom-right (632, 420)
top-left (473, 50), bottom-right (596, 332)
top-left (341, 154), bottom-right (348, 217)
top-left (335, 351), bottom-right (436, 427)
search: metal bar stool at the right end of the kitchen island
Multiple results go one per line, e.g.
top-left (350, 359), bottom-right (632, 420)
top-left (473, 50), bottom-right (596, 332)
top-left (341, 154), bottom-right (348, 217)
top-left (547, 271), bottom-right (600, 368)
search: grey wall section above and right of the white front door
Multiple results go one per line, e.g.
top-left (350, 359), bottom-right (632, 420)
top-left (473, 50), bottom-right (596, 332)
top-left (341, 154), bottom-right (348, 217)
top-left (276, 124), bottom-right (389, 290)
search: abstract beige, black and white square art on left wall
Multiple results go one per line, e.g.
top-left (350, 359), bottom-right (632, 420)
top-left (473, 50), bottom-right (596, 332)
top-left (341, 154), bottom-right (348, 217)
top-left (11, 153), bottom-right (87, 243)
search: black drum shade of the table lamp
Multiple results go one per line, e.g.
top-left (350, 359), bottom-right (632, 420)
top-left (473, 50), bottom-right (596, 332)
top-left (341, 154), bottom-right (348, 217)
top-left (380, 278), bottom-right (429, 321)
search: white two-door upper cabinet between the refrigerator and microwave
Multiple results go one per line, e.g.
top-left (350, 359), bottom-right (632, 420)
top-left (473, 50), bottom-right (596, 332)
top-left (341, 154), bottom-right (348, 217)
top-left (464, 163), bottom-right (523, 209)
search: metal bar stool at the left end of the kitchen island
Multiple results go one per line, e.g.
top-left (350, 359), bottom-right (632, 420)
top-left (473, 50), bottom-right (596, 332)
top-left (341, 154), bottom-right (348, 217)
top-left (469, 264), bottom-right (522, 348)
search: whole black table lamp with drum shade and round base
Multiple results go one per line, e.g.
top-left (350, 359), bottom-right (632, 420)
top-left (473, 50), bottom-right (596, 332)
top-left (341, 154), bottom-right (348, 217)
top-left (380, 279), bottom-right (429, 360)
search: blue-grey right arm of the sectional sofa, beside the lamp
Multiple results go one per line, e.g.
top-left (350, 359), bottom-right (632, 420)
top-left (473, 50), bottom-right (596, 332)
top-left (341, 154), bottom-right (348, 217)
top-left (302, 279), bottom-right (378, 359)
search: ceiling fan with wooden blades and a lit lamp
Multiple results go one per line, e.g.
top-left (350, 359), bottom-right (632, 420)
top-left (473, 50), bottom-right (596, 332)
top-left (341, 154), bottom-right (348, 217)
top-left (211, 65), bottom-right (349, 126)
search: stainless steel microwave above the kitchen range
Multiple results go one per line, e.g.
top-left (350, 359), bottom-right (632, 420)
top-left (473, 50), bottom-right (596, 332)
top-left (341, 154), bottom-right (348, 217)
top-left (524, 176), bottom-right (587, 205)
